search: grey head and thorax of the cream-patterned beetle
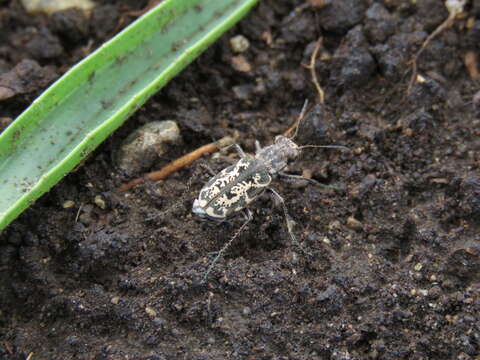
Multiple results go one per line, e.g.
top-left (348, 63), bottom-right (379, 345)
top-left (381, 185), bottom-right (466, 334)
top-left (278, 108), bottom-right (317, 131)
top-left (255, 135), bottom-right (300, 174)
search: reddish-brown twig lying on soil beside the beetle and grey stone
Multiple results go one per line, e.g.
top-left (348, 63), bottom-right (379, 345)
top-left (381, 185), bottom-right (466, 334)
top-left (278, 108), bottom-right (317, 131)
top-left (117, 136), bottom-right (235, 191)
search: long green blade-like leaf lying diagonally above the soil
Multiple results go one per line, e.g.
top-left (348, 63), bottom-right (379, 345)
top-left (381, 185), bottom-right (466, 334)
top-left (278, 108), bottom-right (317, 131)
top-left (0, 0), bottom-right (258, 230)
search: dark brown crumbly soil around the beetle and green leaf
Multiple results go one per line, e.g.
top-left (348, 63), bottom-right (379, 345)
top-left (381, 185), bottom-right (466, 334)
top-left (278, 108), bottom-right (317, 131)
top-left (0, 0), bottom-right (480, 360)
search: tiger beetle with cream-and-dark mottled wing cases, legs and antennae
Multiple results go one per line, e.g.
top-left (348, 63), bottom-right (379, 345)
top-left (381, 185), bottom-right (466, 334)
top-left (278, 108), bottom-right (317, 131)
top-left (192, 102), bottom-right (347, 282)
